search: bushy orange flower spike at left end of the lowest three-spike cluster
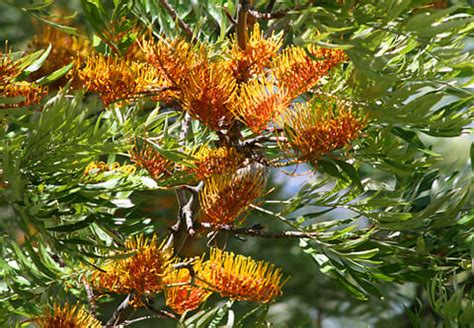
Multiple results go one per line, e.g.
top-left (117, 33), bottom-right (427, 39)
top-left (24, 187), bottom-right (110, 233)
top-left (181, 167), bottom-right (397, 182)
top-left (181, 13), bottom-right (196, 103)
top-left (93, 235), bottom-right (174, 305)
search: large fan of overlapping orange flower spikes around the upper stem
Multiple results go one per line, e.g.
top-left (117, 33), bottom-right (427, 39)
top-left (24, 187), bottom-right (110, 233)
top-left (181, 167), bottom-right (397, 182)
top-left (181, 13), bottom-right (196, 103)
top-left (144, 25), bottom-right (346, 134)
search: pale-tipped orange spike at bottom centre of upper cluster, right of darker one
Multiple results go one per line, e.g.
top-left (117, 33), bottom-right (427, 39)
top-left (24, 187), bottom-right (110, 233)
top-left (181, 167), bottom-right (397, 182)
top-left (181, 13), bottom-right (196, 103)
top-left (233, 80), bottom-right (289, 134)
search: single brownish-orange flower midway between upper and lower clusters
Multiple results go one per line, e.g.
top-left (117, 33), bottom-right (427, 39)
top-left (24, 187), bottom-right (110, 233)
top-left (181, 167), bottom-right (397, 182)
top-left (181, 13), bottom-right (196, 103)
top-left (199, 166), bottom-right (266, 226)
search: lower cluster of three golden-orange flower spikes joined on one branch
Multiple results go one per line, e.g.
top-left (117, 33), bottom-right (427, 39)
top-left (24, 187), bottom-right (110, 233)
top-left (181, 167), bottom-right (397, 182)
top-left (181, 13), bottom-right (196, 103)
top-left (93, 236), bottom-right (285, 314)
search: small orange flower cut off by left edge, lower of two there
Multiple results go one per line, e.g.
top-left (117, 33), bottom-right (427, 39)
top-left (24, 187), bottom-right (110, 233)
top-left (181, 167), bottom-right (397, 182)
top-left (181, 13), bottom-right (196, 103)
top-left (0, 82), bottom-right (48, 108)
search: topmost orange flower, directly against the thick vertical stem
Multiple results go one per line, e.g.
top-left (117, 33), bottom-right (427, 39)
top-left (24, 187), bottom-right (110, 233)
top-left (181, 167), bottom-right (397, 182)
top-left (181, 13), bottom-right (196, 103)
top-left (229, 24), bottom-right (283, 83)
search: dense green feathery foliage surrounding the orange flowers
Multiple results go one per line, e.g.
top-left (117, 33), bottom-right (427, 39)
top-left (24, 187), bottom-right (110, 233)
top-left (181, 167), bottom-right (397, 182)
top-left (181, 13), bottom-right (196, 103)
top-left (0, 0), bottom-right (474, 328)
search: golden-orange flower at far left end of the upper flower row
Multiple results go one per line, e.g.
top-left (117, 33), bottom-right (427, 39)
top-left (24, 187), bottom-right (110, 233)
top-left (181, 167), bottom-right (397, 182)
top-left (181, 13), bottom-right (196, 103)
top-left (77, 55), bottom-right (162, 106)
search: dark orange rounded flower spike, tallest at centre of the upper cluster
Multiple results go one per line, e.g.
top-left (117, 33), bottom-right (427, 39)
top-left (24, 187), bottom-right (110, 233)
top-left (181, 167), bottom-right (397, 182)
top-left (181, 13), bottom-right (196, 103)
top-left (180, 58), bottom-right (237, 130)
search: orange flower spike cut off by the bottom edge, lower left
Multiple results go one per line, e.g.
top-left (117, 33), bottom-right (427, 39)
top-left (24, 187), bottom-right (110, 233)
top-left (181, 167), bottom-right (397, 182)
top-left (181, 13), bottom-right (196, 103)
top-left (33, 304), bottom-right (102, 328)
